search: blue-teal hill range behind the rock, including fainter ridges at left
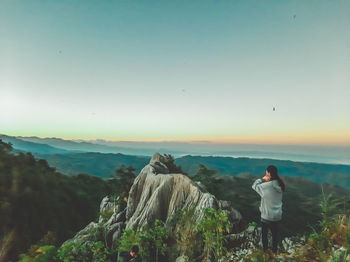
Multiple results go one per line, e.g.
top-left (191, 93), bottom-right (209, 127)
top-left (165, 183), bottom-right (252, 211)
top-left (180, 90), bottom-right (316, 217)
top-left (0, 135), bottom-right (350, 188)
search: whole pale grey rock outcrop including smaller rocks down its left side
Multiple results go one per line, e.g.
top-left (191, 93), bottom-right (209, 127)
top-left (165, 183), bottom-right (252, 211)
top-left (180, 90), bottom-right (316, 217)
top-left (64, 153), bottom-right (242, 246)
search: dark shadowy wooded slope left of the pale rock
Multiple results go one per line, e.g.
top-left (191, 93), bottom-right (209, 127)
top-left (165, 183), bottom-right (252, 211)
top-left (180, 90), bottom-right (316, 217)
top-left (0, 141), bottom-right (118, 261)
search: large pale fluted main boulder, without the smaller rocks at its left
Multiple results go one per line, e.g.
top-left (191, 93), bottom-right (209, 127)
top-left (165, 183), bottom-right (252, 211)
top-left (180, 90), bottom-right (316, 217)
top-left (126, 154), bottom-right (242, 229)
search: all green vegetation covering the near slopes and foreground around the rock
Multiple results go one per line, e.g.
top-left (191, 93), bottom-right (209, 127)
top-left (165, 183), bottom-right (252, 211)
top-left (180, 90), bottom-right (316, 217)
top-left (0, 141), bottom-right (350, 262)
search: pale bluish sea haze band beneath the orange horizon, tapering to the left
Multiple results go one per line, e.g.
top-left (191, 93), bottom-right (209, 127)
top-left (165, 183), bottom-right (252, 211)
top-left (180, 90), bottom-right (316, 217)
top-left (89, 140), bottom-right (350, 165)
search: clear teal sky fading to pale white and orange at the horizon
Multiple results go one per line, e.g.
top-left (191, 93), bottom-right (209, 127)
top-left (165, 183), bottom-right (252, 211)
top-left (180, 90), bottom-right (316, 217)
top-left (0, 0), bottom-right (350, 145)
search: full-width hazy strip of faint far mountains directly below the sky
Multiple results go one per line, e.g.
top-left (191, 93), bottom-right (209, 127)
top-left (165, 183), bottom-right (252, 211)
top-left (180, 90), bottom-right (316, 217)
top-left (0, 135), bottom-right (350, 165)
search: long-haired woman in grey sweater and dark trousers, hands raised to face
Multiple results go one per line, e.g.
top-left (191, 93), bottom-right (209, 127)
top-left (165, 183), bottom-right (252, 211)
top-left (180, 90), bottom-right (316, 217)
top-left (252, 166), bottom-right (286, 253)
